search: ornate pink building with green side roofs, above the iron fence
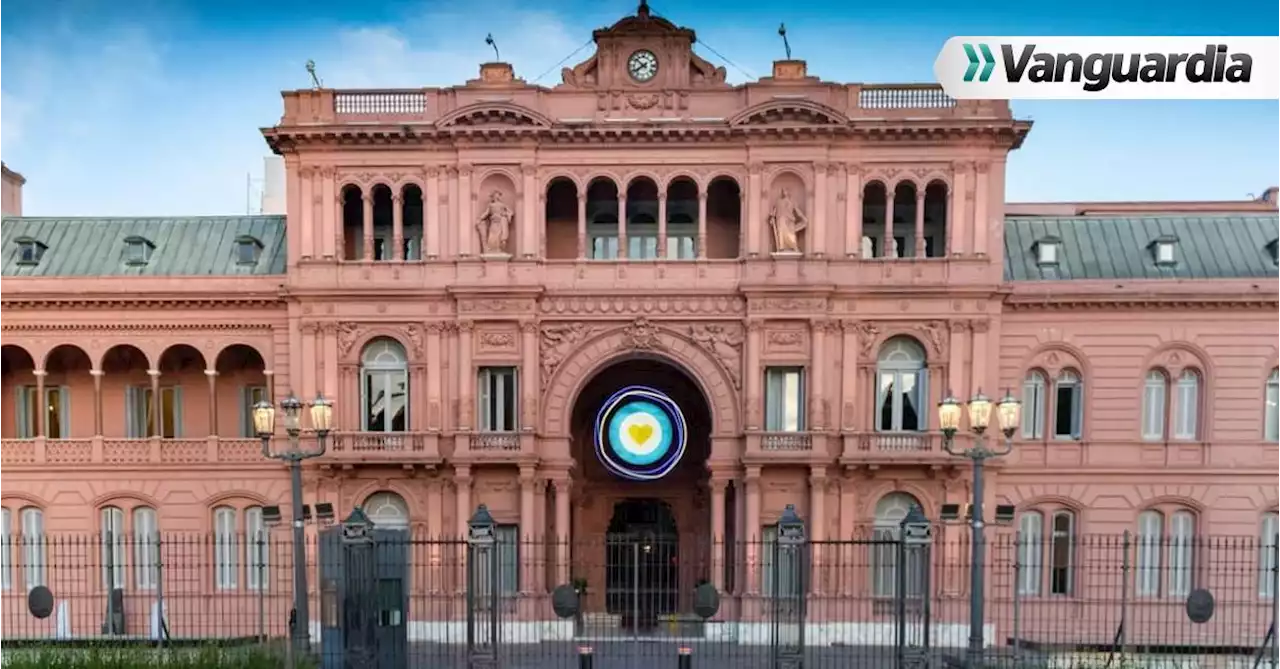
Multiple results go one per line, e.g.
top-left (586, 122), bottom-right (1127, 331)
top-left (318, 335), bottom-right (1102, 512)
top-left (0, 0), bottom-right (1280, 647)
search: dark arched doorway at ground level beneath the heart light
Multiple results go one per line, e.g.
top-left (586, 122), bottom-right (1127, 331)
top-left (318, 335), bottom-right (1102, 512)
top-left (604, 498), bottom-right (680, 633)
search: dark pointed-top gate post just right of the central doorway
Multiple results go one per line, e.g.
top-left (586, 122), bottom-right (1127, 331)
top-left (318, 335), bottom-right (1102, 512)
top-left (765, 504), bottom-right (809, 669)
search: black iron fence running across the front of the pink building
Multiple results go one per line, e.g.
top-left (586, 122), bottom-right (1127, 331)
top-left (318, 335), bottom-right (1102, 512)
top-left (0, 526), bottom-right (1280, 669)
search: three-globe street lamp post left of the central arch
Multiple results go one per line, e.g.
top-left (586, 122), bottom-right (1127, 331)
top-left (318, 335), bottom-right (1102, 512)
top-left (253, 390), bottom-right (333, 654)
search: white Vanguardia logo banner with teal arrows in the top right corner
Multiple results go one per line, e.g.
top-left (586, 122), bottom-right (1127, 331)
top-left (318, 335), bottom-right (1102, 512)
top-left (934, 37), bottom-right (1280, 100)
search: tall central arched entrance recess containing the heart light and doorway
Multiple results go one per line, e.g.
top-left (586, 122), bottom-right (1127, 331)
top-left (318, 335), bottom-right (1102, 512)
top-left (571, 356), bottom-right (712, 634)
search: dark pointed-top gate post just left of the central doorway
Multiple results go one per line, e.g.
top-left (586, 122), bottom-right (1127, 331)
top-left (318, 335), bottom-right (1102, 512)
top-left (466, 504), bottom-right (498, 668)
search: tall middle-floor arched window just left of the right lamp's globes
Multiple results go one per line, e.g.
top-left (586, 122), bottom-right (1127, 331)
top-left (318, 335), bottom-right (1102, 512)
top-left (876, 336), bottom-right (929, 432)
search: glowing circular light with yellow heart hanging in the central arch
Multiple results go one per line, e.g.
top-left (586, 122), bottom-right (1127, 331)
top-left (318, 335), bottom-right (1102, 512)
top-left (595, 385), bottom-right (689, 481)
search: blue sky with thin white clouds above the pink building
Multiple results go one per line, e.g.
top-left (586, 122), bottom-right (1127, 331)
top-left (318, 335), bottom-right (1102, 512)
top-left (0, 0), bottom-right (1280, 216)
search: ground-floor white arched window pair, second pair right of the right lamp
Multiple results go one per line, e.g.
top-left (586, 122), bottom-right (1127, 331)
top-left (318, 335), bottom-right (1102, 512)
top-left (1135, 509), bottom-right (1196, 597)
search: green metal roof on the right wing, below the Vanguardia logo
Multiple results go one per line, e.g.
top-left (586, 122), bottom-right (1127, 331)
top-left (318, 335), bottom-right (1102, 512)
top-left (1005, 214), bottom-right (1280, 281)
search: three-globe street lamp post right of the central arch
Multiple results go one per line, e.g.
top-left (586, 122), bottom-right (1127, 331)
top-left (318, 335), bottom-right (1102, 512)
top-left (938, 390), bottom-right (1021, 668)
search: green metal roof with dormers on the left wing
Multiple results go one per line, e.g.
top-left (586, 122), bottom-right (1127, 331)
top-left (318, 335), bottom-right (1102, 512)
top-left (0, 216), bottom-right (285, 276)
